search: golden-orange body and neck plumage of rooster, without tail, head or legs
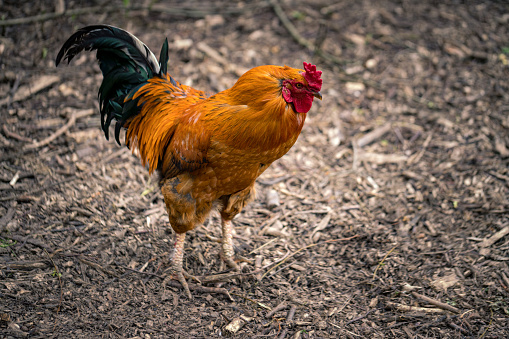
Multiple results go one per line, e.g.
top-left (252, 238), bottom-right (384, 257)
top-left (125, 66), bottom-right (306, 233)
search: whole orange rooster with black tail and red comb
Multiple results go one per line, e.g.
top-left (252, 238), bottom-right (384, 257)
top-left (56, 25), bottom-right (322, 298)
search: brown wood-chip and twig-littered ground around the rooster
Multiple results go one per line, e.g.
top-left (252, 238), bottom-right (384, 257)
top-left (0, 0), bottom-right (509, 338)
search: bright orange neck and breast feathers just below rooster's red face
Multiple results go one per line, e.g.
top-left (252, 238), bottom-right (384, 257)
top-left (207, 66), bottom-right (306, 150)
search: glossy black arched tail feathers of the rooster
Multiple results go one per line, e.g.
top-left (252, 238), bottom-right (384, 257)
top-left (56, 25), bottom-right (176, 144)
